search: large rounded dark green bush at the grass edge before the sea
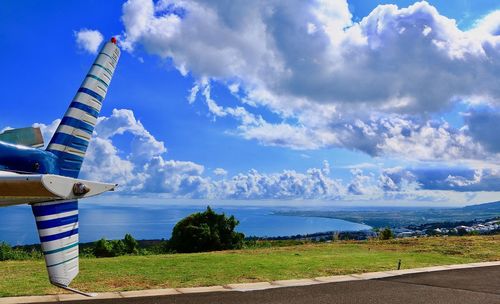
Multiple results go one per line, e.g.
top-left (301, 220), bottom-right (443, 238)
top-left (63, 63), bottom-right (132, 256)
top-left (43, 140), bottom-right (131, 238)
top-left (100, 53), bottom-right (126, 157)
top-left (169, 206), bottom-right (245, 252)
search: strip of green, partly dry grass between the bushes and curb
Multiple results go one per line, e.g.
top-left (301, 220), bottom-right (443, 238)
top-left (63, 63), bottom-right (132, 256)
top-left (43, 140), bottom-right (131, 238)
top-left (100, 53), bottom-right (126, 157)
top-left (0, 235), bottom-right (500, 296)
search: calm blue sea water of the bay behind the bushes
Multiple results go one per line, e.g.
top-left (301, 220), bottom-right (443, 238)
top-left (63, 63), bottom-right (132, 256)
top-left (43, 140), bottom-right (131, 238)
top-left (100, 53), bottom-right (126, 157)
top-left (0, 203), bottom-right (371, 245)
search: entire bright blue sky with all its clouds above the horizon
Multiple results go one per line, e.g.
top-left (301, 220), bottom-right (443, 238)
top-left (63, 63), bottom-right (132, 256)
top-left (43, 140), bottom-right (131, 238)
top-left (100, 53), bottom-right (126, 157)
top-left (0, 0), bottom-right (500, 205)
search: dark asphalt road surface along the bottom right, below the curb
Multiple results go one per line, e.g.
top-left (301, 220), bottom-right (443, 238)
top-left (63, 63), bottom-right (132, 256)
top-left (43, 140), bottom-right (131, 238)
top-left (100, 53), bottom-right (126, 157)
top-left (48, 266), bottom-right (500, 304)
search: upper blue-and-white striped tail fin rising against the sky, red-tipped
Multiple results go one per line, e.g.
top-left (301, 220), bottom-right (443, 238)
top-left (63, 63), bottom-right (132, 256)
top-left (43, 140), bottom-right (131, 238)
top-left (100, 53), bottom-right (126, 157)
top-left (47, 38), bottom-right (120, 178)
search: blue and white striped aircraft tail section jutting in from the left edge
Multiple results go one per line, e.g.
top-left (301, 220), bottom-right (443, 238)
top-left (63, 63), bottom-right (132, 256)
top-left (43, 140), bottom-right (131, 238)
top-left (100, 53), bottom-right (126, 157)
top-left (0, 37), bottom-right (120, 296)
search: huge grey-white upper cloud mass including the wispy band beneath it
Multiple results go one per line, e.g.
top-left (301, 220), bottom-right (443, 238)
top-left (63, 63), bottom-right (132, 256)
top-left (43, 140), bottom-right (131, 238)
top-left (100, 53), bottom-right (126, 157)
top-left (117, 0), bottom-right (500, 165)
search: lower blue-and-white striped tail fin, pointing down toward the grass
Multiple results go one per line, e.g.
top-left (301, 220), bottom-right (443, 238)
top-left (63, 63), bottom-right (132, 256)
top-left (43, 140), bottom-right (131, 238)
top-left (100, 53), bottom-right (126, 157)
top-left (32, 201), bottom-right (78, 286)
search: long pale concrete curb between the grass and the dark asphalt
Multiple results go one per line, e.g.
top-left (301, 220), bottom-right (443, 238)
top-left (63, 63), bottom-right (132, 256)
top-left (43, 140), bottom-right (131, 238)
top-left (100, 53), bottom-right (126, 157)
top-left (0, 261), bottom-right (500, 304)
